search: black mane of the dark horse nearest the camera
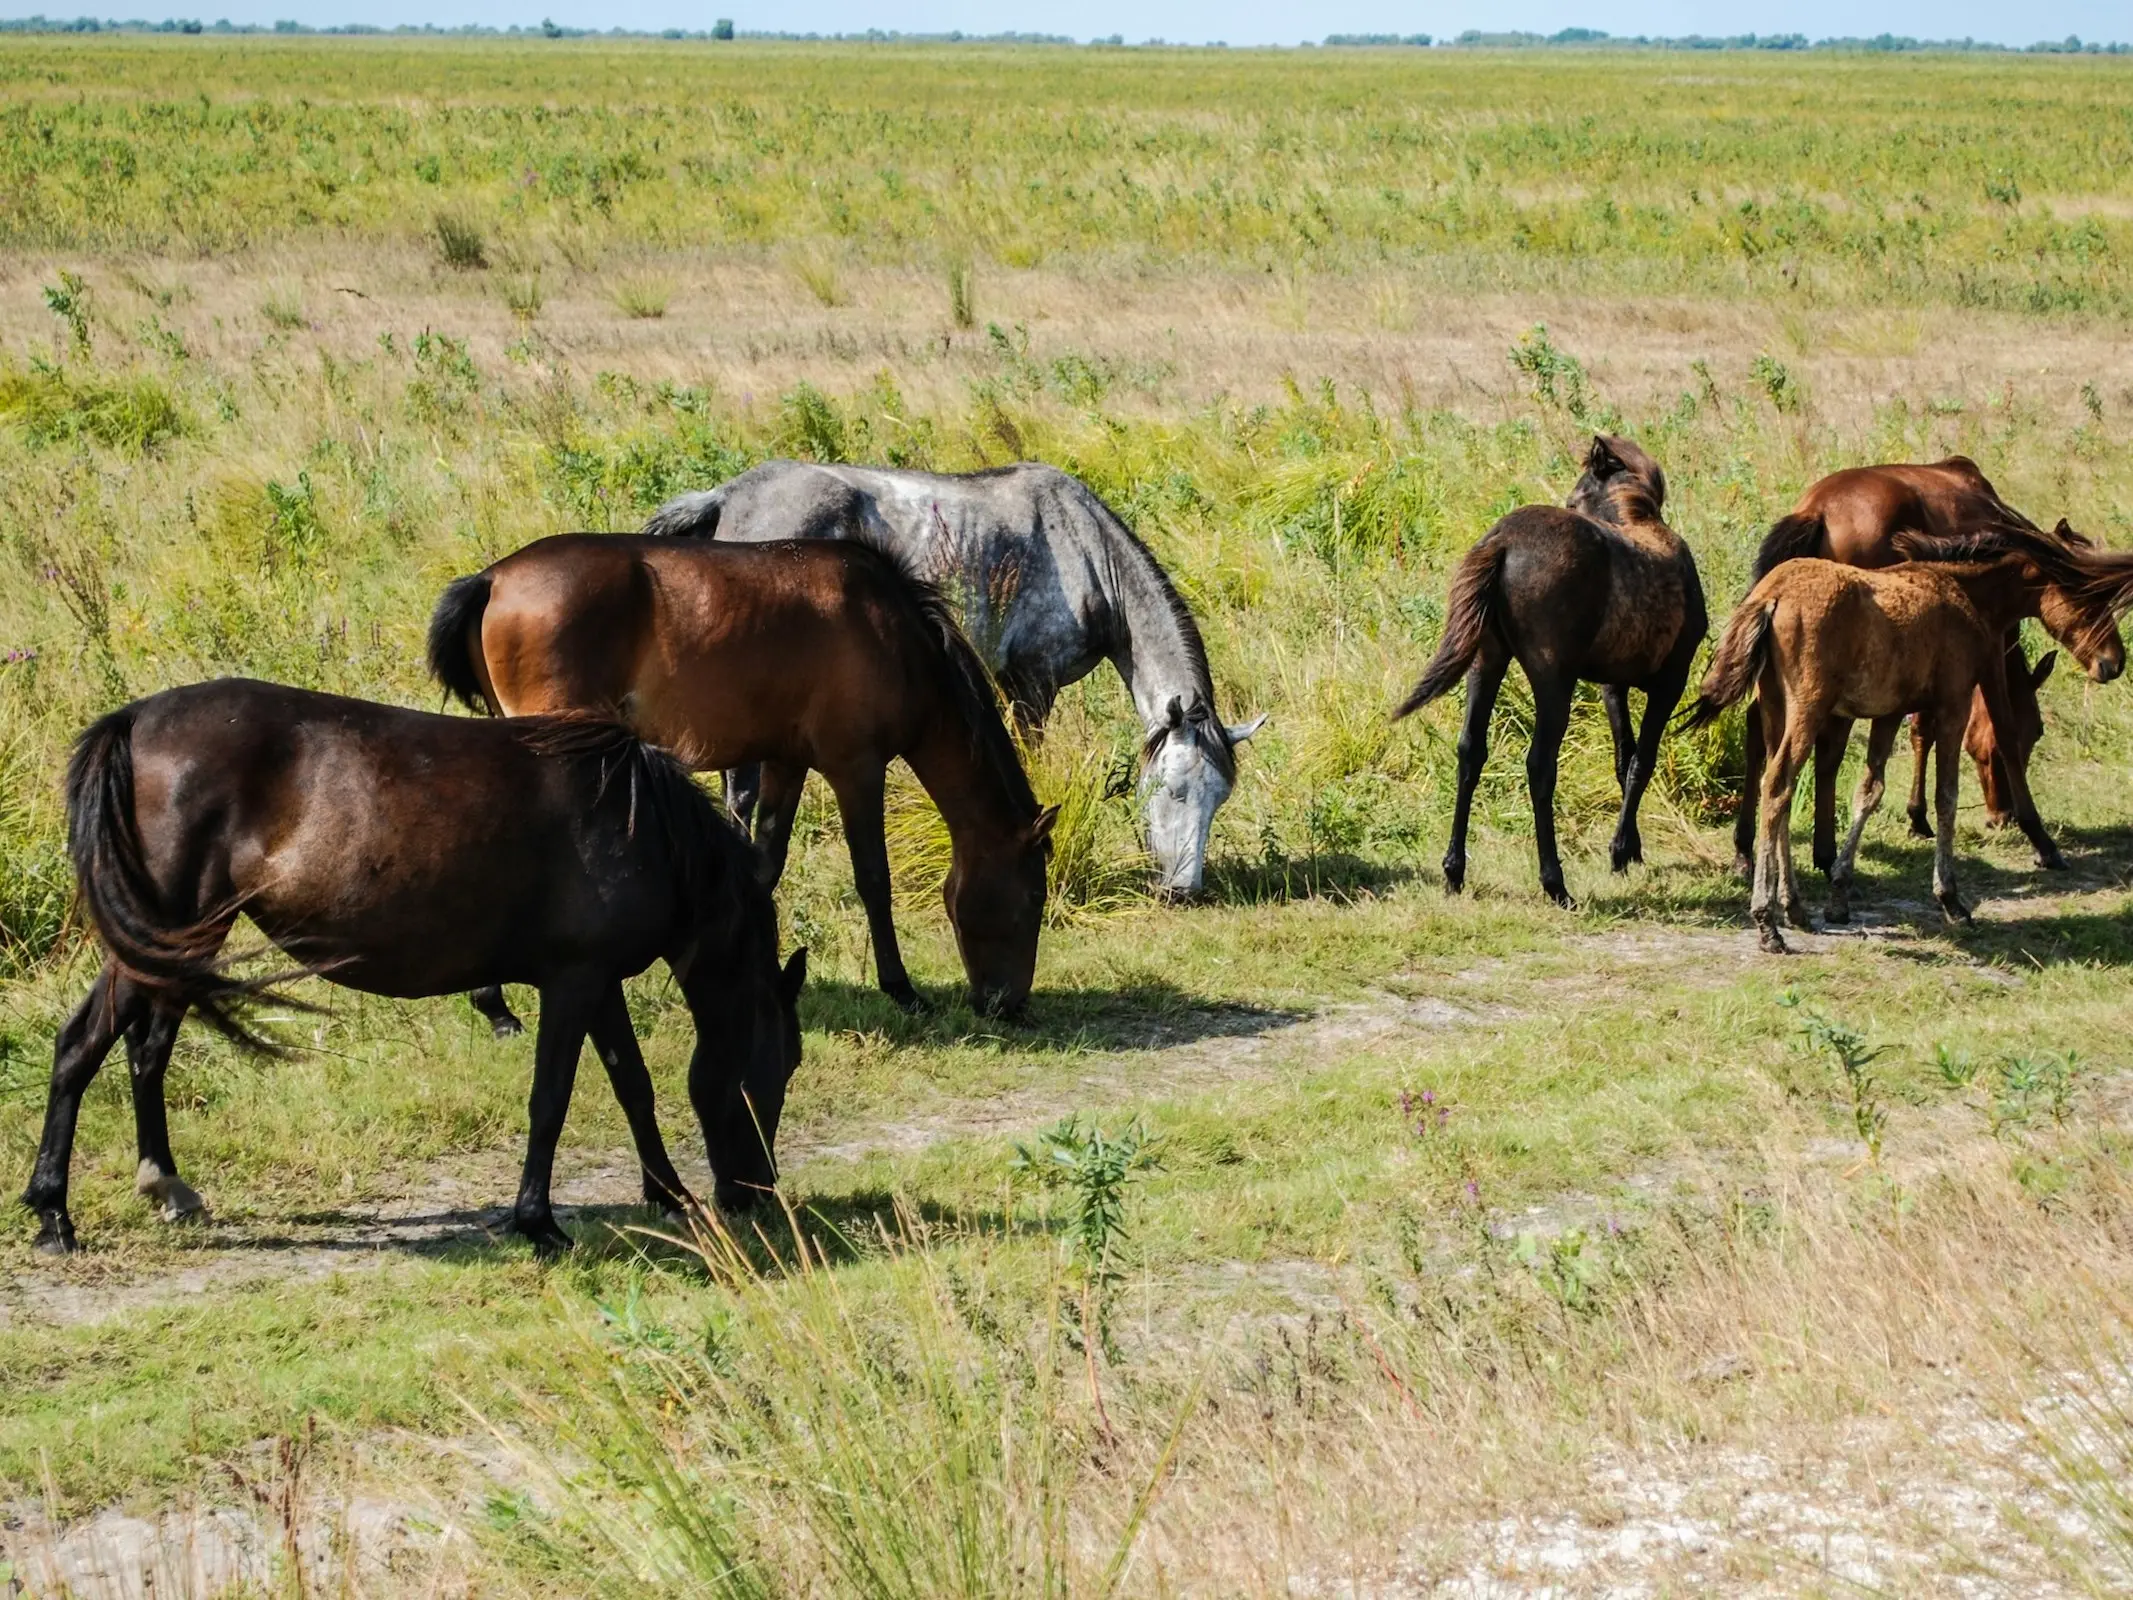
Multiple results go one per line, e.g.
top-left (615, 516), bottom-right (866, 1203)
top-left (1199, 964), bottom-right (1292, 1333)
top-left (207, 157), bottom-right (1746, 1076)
top-left (512, 713), bottom-right (755, 922)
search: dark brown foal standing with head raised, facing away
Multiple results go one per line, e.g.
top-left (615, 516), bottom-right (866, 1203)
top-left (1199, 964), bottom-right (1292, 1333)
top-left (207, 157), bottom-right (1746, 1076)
top-left (1393, 435), bottom-right (1709, 907)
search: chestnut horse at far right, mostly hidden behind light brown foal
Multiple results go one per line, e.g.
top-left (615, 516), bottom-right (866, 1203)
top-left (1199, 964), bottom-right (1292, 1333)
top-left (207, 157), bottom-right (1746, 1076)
top-left (1734, 457), bottom-right (2124, 873)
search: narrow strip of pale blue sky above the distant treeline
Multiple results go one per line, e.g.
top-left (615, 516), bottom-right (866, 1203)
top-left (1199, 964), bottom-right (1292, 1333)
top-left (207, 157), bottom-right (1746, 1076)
top-left (0, 0), bottom-right (2133, 45)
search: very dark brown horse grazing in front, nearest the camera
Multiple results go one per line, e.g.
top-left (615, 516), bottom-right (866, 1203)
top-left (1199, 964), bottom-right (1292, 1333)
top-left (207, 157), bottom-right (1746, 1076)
top-left (23, 678), bottom-right (806, 1254)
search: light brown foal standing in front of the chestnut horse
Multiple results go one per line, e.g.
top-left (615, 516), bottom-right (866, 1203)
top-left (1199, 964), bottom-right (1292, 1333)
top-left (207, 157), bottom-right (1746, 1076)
top-left (1685, 529), bottom-right (2133, 954)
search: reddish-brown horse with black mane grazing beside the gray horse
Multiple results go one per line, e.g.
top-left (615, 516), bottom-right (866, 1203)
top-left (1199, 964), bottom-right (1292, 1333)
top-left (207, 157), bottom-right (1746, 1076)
top-left (429, 533), bottom-right (1058, 1028)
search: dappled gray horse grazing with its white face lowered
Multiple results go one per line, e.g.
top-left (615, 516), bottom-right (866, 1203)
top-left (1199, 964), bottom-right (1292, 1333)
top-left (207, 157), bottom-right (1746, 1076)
top-left (644, 461), bottom-right (1265, 894)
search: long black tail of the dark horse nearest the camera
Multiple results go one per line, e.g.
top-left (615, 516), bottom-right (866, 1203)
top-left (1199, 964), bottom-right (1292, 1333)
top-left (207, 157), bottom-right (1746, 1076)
top-left (66, 706), bottom-right (307, 1054)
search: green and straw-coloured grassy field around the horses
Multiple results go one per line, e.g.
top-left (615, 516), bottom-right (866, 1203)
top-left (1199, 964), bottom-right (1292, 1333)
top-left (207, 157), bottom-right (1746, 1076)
top-left (0, 38), bottom-right (2133, 1596)
